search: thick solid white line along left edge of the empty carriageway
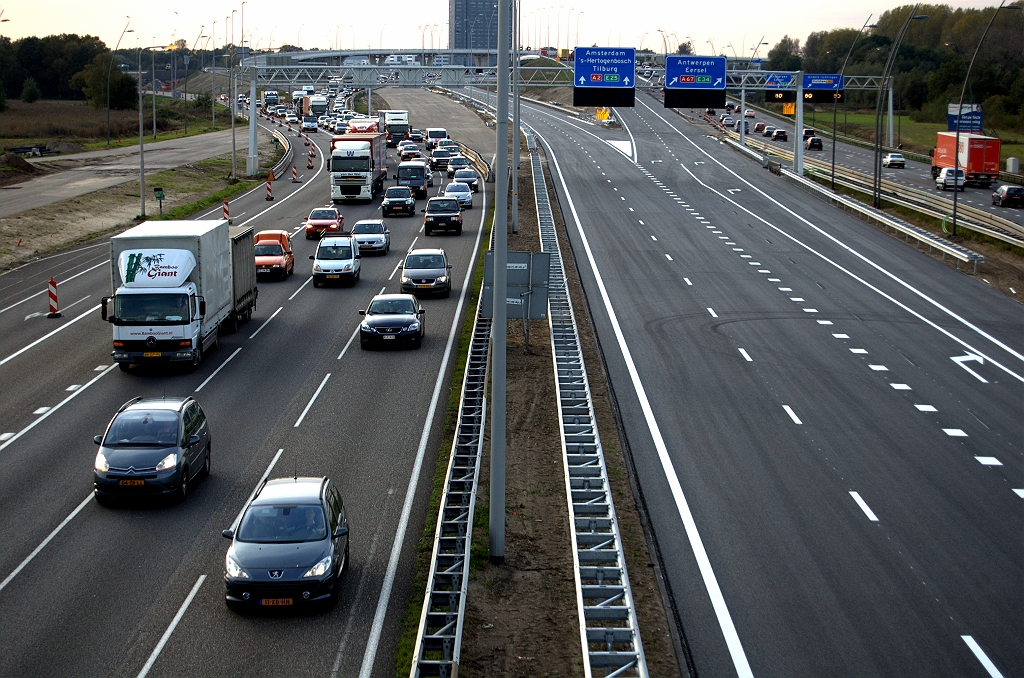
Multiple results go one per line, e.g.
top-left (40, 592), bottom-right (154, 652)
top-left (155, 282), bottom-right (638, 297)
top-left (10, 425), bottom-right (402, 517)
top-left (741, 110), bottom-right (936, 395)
top-left (536, 127), bottom-right (754, 678)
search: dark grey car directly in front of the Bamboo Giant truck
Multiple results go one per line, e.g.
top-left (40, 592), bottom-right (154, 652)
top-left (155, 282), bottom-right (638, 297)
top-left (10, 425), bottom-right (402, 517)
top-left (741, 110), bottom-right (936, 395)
top-left (93, 397), bottom-right (210, 504)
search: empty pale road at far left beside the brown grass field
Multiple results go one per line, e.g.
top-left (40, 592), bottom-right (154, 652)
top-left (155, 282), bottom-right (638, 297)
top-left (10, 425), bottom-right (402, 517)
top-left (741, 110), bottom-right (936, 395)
top-left (0, 126), bottom-right (266, 217)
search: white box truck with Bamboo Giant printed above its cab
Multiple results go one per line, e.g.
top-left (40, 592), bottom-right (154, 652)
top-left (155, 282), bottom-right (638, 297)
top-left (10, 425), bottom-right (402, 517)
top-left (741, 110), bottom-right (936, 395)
top-left (101, 219), bottom-right (259, 372)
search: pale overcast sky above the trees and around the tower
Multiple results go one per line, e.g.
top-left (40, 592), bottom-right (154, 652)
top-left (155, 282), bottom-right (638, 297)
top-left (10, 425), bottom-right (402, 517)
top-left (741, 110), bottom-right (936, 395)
top-left (0, 0), bottom-right (997, 55)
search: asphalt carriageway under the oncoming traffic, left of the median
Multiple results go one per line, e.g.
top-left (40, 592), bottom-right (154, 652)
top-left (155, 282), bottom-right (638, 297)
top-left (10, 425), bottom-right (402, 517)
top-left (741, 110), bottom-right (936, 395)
top-left (0, 92), bottom-right (494, 677)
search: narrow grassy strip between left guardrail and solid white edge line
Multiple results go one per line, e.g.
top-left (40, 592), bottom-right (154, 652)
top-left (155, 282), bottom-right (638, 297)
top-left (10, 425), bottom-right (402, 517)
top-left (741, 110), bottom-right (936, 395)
top-left (394, 203), bottom-right (495, 678)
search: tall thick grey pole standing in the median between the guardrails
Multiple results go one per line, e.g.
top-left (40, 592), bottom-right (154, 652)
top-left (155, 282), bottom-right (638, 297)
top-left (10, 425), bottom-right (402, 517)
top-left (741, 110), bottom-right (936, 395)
top-left (488, 0), bottom-right (505, 564)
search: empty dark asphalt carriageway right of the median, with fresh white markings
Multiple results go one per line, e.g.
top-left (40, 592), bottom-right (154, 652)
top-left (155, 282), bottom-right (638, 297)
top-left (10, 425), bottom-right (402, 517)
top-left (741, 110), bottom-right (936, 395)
top-left (479, 89), bottom-right (1024, 677)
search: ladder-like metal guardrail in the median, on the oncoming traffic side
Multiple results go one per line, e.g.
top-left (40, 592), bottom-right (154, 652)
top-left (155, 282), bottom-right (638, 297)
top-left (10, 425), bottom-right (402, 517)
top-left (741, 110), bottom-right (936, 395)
top-left (410, 303), bottom-right (490, 678)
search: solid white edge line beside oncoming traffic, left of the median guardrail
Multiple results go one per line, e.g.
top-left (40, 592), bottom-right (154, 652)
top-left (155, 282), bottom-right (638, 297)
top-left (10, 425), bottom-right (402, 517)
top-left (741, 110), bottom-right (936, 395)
top-left (359, 170), bottom-right (487, 678)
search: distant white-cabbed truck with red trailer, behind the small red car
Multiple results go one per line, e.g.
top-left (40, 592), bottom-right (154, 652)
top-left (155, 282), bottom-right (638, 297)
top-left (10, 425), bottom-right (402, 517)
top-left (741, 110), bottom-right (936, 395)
top-left (331, 132), bottom-right (387, 203)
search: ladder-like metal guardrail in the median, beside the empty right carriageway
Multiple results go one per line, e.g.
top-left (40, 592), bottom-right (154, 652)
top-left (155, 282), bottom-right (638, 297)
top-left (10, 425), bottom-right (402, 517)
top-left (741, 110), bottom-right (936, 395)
top-left (523, 125), bottom-right (648, 678)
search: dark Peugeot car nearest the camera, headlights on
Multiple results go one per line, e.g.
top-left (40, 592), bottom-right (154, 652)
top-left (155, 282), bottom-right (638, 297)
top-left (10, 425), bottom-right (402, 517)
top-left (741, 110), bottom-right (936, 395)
top-left (223, 477), bottom-right (348, 610)
